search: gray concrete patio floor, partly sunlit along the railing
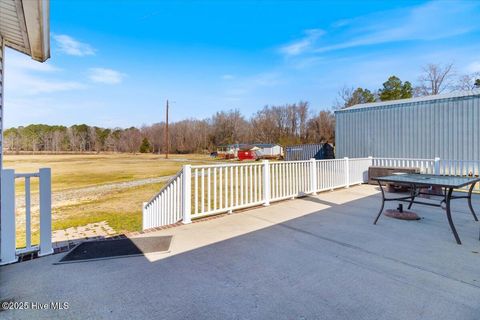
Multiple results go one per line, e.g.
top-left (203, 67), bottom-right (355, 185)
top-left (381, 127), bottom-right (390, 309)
top-left (0, 185), bottom-right (480, 319)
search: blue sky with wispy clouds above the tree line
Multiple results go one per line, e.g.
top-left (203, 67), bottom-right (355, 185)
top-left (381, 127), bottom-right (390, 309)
top-left (5, 0), bottom-right (480, 127)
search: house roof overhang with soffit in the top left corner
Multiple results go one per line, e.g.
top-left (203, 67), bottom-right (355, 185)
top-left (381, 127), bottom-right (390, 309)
top-left (0, 0), bottom-right (50, 62)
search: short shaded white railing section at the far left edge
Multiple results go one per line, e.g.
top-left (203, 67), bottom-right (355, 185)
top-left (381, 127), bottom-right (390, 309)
top-left (0, 168), bottom-right (53, 265)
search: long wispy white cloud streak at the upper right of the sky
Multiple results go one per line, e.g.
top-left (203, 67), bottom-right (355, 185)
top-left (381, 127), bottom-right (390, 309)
top-left (280, 1), bottom-right (479, 56)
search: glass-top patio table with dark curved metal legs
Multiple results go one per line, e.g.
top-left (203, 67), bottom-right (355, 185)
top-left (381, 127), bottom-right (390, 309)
top-left (373, 174), bottom-right (480, 244)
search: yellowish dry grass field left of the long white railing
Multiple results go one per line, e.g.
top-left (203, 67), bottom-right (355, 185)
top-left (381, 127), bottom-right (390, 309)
top-left (4, 154), bottom-right (212, 247)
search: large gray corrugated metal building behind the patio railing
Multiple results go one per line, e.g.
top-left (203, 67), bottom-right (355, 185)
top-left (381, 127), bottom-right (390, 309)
top-left (335, 90), bottom-right (480, 160)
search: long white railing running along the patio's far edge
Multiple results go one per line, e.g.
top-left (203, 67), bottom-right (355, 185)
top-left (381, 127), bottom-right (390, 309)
top-left (143, 157), bottom-right (480, 229)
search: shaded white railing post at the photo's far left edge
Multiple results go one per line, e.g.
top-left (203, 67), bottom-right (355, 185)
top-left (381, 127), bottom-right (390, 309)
top-left (0, 169), bottom-right (17, 265)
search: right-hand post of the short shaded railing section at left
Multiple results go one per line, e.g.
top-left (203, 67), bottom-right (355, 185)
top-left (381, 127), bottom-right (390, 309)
top-left (38, 168), bottom-right (53, 256)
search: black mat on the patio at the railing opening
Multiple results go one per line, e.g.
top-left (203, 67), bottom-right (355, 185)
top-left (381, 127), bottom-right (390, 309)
top-left (59, 236), bottom-right (172, 263)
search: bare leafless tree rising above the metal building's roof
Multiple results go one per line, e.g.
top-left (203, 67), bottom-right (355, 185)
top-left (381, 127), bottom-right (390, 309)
top-left (415, 63), bottom-right (455, 96)
